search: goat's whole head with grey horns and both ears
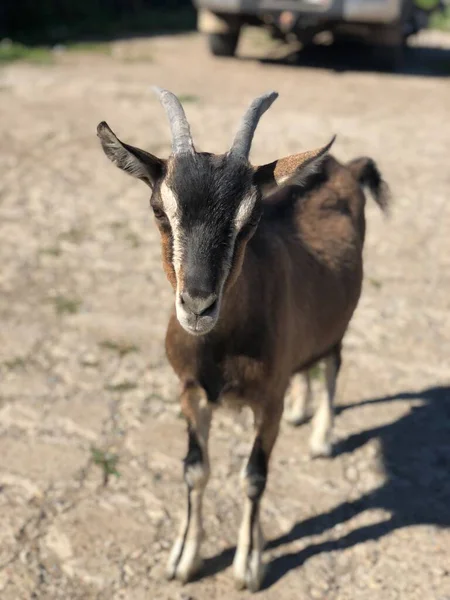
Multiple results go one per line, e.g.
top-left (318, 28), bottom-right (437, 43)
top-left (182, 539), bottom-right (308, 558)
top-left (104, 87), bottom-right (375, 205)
top-left (97, 88), bottom-right (333, 335)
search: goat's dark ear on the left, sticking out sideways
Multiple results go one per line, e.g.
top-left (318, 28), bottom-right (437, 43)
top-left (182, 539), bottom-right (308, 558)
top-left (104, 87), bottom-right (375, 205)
top-left (97, 121), bottom-right (165, 188)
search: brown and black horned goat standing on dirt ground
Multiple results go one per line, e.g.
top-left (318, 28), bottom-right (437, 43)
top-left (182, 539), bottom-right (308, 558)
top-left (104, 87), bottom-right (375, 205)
top-left (97, 88), bottom-right (387, 591)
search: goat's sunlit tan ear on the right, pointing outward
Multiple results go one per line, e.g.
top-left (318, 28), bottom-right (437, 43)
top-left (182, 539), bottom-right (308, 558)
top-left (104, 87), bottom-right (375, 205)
top-left (253, 136), bottom-right (336, 196)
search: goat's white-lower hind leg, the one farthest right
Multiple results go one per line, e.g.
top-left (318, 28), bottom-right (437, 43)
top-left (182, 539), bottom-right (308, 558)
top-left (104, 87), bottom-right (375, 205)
top-left (309, 343), bottom-right (341, 458)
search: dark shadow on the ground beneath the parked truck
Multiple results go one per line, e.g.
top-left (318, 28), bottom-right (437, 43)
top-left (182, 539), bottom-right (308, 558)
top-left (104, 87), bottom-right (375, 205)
top-left (243, 43), bottom-right (450, 77)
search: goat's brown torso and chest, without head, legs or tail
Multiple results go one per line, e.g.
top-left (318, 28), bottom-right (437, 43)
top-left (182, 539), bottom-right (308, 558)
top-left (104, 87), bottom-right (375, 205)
top-left (166, 157), bottom-right (365, 407)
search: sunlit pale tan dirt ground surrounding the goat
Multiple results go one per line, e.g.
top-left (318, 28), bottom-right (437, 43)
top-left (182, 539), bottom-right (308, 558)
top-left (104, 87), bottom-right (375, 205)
top-left (0, 28), bottom-right (450, 600)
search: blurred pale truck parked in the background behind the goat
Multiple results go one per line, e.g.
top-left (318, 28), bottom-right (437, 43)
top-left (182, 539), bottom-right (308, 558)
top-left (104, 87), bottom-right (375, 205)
top-left (194, 0), bottom-right (443, 70)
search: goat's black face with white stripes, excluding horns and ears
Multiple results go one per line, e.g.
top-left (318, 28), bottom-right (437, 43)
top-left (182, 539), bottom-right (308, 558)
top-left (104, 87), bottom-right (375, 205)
top-left (161, 153), bottom-right (260, 334)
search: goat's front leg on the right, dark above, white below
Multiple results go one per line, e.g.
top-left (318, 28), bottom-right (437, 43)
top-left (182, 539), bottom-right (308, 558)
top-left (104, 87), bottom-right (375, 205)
top-left (233, 399), bottom-right (283, 592)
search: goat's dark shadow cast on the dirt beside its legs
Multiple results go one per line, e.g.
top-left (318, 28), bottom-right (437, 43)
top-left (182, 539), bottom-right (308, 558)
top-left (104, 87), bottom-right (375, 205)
top-left (201, 386), bottom-right (450, 589)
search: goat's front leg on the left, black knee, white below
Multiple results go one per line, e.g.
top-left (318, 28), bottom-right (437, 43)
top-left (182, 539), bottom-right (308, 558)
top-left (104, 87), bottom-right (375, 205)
top-left (167, 386), bottom-right (212, 582)
